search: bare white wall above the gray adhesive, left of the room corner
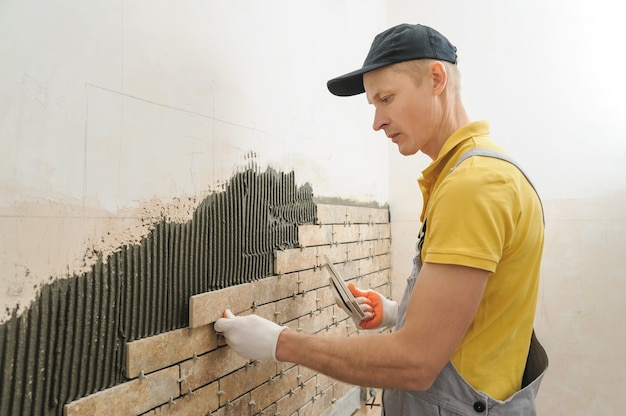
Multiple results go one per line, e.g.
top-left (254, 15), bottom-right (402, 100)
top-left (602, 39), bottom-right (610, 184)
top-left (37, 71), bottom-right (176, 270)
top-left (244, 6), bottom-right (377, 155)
top-left (0, 0), bottom-right (388, 320)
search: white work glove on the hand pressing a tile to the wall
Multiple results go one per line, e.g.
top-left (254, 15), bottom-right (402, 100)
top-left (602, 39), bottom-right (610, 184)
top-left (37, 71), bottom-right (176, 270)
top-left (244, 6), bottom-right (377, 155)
top-left (214, 309), bottom-right (287, 361)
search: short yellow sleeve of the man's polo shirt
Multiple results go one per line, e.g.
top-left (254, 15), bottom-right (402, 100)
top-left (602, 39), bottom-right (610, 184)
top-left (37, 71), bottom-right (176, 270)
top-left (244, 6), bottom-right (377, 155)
top-left (422, 157), bottom-right (520, 272)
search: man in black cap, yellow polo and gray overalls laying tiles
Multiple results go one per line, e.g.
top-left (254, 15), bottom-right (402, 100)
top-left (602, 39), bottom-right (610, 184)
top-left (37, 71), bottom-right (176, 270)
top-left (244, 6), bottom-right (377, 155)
top-left (215, 24), bottom-right (547, 416)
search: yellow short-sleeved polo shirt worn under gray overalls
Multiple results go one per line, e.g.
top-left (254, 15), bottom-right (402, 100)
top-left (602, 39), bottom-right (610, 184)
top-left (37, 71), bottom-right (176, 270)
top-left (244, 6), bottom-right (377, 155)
top-left (419, 121), bottom-right (544, 400)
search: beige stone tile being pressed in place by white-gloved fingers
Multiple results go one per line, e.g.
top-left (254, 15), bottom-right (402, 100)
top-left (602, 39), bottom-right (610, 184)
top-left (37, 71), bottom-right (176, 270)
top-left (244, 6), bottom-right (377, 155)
top-left (189, 283), bottom-right (254, 328)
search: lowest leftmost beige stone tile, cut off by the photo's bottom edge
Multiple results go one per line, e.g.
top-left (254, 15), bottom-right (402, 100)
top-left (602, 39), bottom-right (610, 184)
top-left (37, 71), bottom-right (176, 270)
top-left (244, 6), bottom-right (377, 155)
top-left (64, 366), bottom-right (180, 416)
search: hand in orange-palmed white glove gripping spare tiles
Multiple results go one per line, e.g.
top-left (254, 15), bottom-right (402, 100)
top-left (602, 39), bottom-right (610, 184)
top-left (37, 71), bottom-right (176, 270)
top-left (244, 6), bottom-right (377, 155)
top-left (348, 282), bottom-right (398, 329)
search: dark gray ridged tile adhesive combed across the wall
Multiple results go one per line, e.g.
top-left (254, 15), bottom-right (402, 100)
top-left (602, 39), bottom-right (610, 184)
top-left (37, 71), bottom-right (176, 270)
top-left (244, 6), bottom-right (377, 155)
top-left (0, 169), bottom-right (316, 416)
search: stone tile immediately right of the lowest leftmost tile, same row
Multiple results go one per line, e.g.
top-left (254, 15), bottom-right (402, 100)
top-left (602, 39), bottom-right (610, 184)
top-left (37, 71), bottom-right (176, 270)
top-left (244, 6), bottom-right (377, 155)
top-left (180, 347), bottom-right (248, 394)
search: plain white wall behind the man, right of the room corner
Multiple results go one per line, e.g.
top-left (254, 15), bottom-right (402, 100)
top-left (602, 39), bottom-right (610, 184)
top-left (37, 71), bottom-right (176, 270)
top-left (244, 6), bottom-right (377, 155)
top-left (388, 0), bottom-right (626, 416)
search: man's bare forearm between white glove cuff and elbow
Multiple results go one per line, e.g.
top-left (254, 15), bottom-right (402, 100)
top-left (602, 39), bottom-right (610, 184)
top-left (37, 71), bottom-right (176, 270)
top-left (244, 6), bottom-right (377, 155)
top-left (276, 330), bottom-right (438, 390)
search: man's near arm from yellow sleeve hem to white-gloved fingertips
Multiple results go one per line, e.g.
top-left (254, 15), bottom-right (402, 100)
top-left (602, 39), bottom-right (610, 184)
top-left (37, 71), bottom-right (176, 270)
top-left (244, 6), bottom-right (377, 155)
top-left (215, 263), bottom-right (488, 390)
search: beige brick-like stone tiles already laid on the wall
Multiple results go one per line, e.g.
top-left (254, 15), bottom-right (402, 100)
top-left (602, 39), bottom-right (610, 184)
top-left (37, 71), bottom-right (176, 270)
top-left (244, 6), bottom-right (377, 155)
top-left (64, 205), bottom-right (391, 416)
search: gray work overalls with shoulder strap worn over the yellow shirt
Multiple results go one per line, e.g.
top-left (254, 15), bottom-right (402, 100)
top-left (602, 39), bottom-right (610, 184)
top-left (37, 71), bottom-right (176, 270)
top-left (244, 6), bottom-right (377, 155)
top-left (383, 149), bottom-right (548, 416)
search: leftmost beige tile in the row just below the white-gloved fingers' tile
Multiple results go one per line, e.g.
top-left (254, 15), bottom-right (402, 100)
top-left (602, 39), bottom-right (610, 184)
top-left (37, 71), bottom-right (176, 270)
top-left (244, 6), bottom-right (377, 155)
top-left (126, 325), bottom-right (217, 378)
